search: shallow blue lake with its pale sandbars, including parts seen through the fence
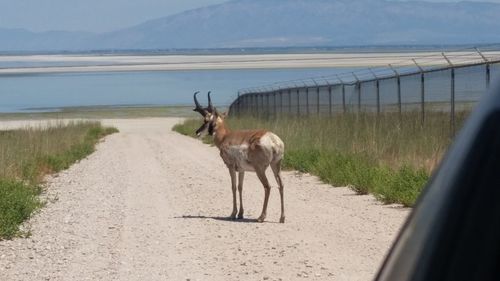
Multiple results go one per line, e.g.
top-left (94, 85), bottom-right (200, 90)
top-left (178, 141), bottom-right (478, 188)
top-left (5, 49), bottom-right (492, 112)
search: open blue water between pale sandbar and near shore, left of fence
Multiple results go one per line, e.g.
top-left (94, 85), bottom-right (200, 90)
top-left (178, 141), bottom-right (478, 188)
top-left (0, 68), bottom-right (360, 112)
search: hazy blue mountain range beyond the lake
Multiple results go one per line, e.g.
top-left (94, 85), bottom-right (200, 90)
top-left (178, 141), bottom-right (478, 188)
top-left (0, 0), bottom-right (500, 50)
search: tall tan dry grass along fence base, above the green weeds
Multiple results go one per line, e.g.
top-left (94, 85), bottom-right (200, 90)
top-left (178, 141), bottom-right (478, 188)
top-left (228, 112), bottom-right (468, 173)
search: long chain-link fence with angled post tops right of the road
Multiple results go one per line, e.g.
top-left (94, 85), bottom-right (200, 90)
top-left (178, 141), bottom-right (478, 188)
top-left (229, 48), bottom-right (500, 131)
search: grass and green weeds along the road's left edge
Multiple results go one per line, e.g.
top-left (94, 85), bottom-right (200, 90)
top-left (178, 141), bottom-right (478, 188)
top-left (0, 121), bottom-right (117, 239)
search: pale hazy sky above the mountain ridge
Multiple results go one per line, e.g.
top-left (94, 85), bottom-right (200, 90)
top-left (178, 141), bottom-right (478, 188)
top-left (0, 0), bottom-right (500, 32)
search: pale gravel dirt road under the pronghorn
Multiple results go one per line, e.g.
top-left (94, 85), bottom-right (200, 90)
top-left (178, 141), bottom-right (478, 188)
top-left (0, 119), bottom-right (408, 280)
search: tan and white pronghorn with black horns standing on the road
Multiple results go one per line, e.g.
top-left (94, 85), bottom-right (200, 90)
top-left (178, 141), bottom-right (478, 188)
top-left (194, 92), bottom-right (285, 223)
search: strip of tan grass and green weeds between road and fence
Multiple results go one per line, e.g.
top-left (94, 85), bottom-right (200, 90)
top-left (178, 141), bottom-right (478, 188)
top-left (174, 112), bottom-right (467, 206)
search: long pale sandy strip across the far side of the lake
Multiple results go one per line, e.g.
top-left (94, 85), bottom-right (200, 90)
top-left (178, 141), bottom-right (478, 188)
top-left (0, 51), bottom-right (500, 75)
